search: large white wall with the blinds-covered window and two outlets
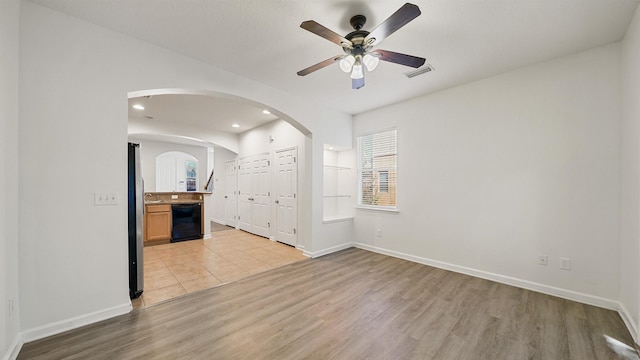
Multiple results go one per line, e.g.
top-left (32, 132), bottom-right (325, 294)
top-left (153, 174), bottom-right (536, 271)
top-left (354, 44), bottom-right (624, 306)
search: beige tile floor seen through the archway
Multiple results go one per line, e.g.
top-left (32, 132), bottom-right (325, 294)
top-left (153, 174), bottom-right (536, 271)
top-left (132, 230), bottom-right (307, 308)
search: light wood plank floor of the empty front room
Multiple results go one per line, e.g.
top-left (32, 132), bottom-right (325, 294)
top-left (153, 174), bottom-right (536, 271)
top-left (18, 249), bottom-right (636, 360)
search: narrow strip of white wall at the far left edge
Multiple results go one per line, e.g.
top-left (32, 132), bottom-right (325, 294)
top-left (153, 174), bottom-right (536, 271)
top-left (0, 0), bottom-right (20, 358)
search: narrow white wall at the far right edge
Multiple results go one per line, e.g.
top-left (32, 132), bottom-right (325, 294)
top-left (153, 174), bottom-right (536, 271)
top-left (620, 3), bottom-right (640, 342)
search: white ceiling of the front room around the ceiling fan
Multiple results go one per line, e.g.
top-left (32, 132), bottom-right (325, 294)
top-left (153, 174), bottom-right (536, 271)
top-left (32, 0), bottom-right (639, 116)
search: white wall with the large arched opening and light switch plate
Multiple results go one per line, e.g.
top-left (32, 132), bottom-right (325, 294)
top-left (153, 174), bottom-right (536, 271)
top-left (14, 2), bottom-right (351, 340)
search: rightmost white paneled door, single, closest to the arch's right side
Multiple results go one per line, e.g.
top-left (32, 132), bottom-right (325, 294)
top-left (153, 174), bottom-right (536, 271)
top-left (275, 149), bottom-right (298, 246)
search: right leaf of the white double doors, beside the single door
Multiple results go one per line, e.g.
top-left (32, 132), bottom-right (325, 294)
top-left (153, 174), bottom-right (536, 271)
top-left (251, 154), bottom-right (271, 237)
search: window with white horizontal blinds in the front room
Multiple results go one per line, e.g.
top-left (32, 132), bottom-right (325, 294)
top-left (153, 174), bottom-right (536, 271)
top-left (357, 129), bottom-right (398, 209)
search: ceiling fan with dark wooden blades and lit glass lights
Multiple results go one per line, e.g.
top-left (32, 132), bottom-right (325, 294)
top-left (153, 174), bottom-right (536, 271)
top-left (298, 3), bottom-right (425, 89)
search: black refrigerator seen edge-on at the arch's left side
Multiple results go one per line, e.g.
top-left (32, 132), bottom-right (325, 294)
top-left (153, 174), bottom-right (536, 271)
top-left (127, 143), bottom-right (144, 299)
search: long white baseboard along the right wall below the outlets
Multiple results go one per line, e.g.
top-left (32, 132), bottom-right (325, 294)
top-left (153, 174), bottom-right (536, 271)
top-left (353, 243), bottom-right (620, 310)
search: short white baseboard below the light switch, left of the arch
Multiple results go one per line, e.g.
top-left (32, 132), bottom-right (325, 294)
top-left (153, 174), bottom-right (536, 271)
top-left (22, 302), bottom-right (132, 343)
